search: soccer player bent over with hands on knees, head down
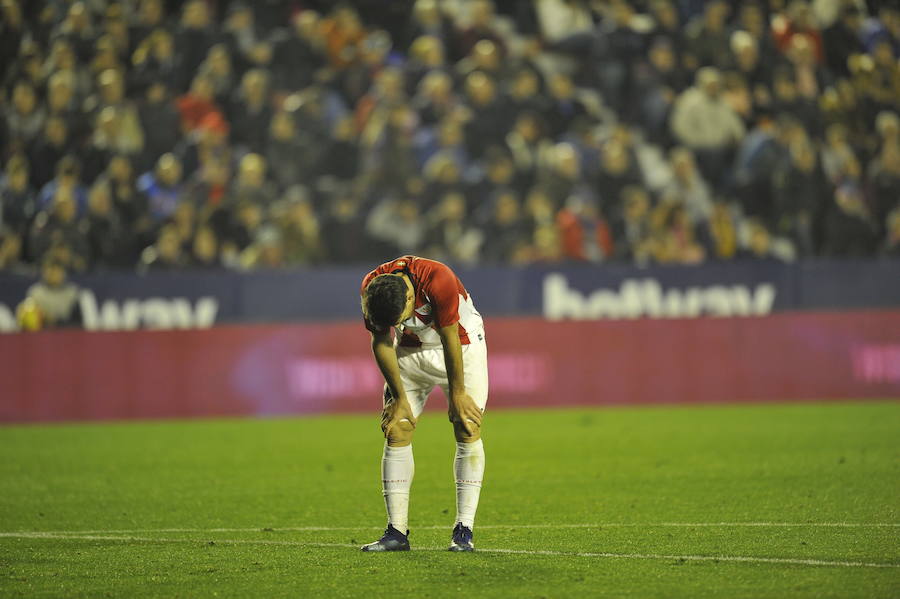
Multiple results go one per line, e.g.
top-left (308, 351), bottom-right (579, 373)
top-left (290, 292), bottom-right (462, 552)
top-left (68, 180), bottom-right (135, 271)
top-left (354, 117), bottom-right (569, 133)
top-left (361, 256), bottom-right (488, 551)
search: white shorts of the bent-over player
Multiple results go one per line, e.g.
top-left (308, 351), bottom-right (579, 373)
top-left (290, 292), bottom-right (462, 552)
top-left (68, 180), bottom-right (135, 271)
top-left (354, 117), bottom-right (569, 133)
top-left (384, 330), bottom-right (488, 418)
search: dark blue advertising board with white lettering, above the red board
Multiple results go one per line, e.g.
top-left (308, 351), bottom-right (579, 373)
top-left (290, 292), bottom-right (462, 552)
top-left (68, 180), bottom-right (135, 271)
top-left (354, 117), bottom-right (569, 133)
top-left (0, 260), bottom-right (900, 332)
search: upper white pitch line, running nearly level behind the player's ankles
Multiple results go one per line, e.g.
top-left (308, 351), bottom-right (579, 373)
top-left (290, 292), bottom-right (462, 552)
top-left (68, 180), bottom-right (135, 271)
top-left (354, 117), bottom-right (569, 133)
top-left (0, 522), bottom-right (900, 537)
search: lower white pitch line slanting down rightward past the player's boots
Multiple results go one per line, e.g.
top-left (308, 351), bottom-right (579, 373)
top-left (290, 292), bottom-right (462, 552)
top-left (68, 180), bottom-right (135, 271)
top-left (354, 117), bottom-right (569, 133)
top-left (7, 533), bottom-right (900, 568)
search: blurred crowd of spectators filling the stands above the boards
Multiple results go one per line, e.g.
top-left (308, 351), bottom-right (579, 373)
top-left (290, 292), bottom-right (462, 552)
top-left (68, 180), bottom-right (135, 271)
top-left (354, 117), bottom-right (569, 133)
top-left (0, 0), bottom-right (900, 278)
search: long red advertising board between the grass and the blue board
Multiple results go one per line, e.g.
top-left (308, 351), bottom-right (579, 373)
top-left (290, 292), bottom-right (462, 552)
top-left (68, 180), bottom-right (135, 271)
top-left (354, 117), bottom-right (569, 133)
top-left (0, 310), bottom-right (900, 422)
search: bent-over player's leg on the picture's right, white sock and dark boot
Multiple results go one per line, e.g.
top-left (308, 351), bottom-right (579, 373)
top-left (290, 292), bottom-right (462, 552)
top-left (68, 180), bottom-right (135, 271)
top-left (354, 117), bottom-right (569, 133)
top-left (444, 336), bottom-right (488, 551)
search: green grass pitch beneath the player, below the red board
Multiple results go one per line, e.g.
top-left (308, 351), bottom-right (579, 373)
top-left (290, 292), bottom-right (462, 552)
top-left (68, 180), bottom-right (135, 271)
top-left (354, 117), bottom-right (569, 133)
top-left (0, 401), bottom-right (900, 599)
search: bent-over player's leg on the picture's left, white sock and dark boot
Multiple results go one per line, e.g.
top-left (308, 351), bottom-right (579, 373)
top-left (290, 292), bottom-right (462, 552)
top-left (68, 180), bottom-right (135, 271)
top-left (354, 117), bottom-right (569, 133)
top-left (362, 358), bottom-right (430, 551)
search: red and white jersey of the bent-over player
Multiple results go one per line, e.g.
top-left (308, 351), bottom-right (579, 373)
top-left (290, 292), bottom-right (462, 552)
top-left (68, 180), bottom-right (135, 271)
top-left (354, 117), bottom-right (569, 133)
top-left (360, 256), bottom-right (484, 347)
